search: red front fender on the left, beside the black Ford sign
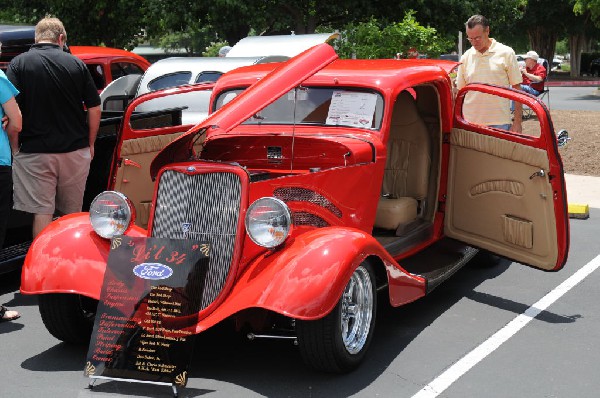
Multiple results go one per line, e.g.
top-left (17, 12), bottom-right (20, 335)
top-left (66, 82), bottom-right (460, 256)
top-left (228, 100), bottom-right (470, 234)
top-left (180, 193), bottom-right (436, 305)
top-left (21, 213), bottom-right (146, 300)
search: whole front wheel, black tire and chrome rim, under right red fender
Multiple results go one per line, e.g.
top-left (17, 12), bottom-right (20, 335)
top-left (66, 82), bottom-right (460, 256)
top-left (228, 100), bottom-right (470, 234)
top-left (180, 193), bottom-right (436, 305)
top-left (296, 263), bottom-right (377, 373)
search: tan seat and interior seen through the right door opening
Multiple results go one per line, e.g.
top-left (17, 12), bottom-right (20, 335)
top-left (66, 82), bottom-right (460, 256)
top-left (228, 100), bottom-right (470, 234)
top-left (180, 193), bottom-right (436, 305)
top-left (375, 85), bottom-right (441, 236)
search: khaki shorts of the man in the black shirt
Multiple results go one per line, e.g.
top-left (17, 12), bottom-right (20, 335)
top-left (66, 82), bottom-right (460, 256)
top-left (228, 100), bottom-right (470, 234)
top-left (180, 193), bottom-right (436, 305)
top-left (13, 148), bottom-right (92, 214)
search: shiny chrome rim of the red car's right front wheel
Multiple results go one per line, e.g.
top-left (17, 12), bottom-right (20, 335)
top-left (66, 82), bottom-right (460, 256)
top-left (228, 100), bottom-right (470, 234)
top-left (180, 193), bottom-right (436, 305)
top-left (340, 266), bottom-right (373, 354)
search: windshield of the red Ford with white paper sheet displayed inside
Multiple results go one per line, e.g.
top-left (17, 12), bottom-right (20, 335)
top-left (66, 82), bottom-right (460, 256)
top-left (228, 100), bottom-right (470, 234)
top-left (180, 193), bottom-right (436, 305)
top-left (216, 87), bottom-right (383, 130)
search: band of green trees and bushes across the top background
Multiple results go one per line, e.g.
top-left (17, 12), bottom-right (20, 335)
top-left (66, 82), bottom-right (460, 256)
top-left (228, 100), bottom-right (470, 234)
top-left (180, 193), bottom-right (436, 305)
top-left (0, 0), bottom-right (600, 58)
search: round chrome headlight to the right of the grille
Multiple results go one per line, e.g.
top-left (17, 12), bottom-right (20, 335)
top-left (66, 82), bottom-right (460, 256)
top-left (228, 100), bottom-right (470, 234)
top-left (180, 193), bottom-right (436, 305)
top-left (246, 197), bottom-right (292, 249)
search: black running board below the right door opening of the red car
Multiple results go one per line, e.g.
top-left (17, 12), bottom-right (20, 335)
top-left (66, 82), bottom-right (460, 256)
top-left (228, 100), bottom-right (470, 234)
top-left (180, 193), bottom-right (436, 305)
top-left (400, 238), bottom-right (478, 294)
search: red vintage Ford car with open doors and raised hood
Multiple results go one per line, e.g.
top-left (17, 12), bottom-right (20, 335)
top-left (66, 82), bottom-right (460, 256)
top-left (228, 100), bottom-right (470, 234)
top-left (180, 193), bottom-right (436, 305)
top-left (21, 44), bottom-right (569, 372)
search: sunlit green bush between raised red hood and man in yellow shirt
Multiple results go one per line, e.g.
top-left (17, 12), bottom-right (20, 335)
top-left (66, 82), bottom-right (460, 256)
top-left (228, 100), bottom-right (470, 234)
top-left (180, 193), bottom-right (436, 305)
top-left (334, 11), bottom-right (452, 59)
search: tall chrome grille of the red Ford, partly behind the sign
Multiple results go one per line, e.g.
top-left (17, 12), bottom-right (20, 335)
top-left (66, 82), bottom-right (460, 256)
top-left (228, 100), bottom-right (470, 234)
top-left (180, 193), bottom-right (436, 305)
top-left (152, 170), bottom-right (241, 309)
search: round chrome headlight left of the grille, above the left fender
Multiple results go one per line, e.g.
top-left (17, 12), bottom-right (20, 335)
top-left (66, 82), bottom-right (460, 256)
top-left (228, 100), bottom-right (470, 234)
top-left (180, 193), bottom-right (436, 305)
top-left (90, 191), bottom-right (135, 239)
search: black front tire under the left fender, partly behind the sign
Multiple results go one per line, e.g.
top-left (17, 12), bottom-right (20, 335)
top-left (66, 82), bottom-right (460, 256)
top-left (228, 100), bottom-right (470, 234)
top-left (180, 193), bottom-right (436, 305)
top-left (39, 293), bottom-right (98, 344)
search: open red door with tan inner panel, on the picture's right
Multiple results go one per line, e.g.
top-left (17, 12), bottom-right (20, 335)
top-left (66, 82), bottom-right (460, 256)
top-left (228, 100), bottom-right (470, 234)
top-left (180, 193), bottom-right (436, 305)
top-left (444, 84), bottom-right (569, 271)
